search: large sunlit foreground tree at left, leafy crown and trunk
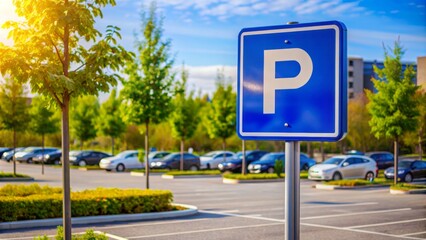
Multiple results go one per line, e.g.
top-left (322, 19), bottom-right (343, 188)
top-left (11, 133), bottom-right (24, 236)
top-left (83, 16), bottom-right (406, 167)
top-left (0, 0), bottom-right (130, 236)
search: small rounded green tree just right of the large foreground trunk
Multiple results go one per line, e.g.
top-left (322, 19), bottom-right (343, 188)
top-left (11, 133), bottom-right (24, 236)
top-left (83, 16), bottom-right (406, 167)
top-left (71, 96), bottom-right (99, 150)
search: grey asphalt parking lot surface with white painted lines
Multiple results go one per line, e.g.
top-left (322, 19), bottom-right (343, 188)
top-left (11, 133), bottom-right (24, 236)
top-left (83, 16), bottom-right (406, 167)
top-left (0, 161), bottom-right (426, 240)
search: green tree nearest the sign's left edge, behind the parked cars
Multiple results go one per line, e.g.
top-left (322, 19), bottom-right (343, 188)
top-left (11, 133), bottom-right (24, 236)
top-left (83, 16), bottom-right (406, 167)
top-left (203, 71), bottom-right (237, 153)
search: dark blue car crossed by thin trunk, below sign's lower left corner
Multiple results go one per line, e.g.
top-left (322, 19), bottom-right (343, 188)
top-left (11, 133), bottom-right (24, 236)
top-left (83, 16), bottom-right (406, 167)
top-left (218, 150), bottom-right (268, 173)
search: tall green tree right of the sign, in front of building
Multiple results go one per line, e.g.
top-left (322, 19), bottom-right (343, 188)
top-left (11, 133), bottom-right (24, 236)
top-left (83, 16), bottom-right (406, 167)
top-left (367, 41), bottom-right (419, 184)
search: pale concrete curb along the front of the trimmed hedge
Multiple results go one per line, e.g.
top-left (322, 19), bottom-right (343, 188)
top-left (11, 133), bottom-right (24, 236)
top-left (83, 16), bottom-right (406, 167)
top-left (0, 204), bottom-right (198, 230)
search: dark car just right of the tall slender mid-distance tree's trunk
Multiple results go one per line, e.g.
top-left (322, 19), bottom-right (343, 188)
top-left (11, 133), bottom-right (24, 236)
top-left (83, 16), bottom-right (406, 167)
top-left (151, 152), bottom-right (201, 171)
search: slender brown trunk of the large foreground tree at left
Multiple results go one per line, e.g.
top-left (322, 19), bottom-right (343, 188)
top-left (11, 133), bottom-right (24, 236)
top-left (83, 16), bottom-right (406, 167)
top-left (62, 93), bottom-right (71, 240)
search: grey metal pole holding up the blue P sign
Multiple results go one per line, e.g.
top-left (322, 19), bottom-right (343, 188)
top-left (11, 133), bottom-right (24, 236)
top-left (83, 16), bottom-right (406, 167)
top-left (284, 141), bottom-right (300, 240)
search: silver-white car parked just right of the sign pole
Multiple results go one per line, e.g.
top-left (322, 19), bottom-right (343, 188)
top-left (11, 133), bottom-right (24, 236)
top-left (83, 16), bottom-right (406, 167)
top-left (308, 155), bottom-right (378, 180)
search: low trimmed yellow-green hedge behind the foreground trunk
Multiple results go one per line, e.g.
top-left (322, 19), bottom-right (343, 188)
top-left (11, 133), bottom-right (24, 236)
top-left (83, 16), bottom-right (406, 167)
top-left (0, 184), bottom-right (173, 222)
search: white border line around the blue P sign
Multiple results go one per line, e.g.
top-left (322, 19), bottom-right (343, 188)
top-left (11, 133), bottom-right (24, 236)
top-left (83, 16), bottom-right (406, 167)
top-left (238, 25), bottom-right (340, 138)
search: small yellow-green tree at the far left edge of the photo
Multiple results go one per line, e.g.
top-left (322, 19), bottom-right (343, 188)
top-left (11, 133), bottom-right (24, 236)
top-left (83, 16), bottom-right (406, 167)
top-left (0, 77), bottom-right (30, 176)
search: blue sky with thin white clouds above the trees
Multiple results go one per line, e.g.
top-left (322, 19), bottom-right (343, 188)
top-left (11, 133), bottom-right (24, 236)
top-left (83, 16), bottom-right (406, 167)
top-left (0, 0), bottom-right (426, 97)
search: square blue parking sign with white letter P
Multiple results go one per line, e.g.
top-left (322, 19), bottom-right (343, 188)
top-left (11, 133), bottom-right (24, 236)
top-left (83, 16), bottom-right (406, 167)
top-left (237, 21), bottom-right (347, 141)
